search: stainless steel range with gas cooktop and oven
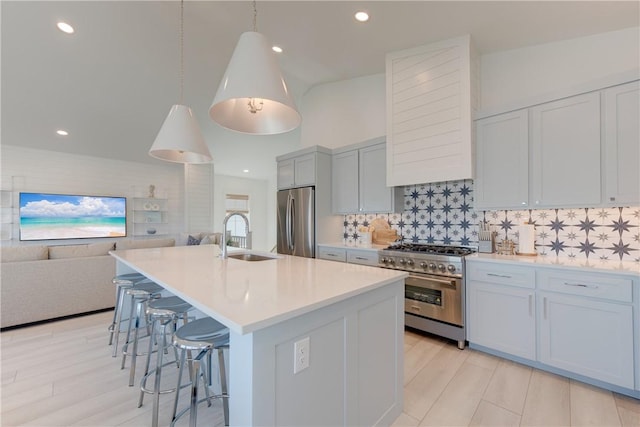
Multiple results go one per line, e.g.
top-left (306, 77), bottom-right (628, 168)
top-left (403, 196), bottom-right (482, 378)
top-left (378, 243), bottom-right (475, 350)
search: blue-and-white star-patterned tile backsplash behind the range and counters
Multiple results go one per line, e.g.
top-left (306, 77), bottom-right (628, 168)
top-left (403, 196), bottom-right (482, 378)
top-left (344, 180), bottom-right (640, 262)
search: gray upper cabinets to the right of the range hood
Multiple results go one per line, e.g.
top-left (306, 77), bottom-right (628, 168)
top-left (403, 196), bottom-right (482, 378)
top-left (475, 80), bottom-right (640, 209)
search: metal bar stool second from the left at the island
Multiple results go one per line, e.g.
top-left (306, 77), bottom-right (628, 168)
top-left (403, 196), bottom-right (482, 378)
top-left (120, 280), bottom-right (163, 387)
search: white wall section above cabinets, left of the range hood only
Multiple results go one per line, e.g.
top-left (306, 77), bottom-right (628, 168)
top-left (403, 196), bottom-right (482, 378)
top-left (300, 74), bottom-right (386, 148)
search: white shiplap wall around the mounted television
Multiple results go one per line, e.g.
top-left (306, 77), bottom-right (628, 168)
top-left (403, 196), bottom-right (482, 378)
top-left (1, 145), bottom-right (184, 245)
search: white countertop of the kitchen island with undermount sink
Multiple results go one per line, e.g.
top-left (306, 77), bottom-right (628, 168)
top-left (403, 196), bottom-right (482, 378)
top-left (110, 245), bottom-right (408, 334)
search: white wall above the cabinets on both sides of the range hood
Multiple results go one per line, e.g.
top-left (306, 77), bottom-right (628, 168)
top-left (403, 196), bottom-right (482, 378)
top-left (300, 27), bottom-right (640, 148)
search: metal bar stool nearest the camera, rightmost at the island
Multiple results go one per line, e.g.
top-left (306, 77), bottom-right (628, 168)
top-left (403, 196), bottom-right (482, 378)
top-left (171, 317), bottom-right (229, 427)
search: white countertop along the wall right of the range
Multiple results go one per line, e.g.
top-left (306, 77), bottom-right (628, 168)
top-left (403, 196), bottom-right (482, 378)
top-left (465, 253), bottom-right (640, 278)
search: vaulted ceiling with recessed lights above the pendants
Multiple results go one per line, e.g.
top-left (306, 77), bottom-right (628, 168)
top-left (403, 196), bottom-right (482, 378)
top-left (1, 0), bottom-right (639, 178)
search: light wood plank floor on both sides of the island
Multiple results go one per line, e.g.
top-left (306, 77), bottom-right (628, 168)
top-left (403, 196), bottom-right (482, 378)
top-left (0, 312), bottom-right (640, 427)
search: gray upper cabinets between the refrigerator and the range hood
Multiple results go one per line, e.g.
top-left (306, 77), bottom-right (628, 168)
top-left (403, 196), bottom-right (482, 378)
top-left (331, 143), bottom-right (403, 214)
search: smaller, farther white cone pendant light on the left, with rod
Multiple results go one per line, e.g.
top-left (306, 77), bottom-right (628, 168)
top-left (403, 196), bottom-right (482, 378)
top-left (149, 0), bottom-right (212, 163)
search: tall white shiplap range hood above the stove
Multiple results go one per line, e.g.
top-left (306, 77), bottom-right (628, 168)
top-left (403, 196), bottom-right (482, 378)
top-left (386, 36), bottom-right (478, 186)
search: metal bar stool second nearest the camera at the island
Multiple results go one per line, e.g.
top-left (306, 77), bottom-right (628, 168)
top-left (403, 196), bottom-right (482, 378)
top-left (138, 296), bottom-right (193, 427)
